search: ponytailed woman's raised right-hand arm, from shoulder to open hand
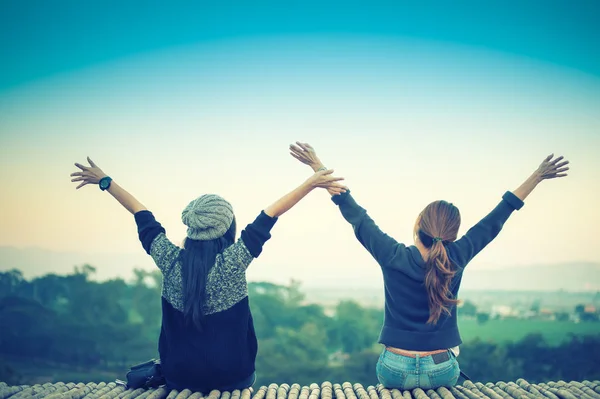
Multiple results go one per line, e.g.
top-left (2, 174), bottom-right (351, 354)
top-left (448, 155), bottom-right (569, 267)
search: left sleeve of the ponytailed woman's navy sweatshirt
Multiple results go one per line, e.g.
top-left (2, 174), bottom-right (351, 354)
top-left (331, 190), bottom-right (406, 267)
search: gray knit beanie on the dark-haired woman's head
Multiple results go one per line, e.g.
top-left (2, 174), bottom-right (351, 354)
top-left (181, 194), bottom-right (233, 241)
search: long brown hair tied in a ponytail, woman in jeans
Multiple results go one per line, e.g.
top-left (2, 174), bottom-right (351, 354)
top-left (415, 201), bottom-right (460, 324)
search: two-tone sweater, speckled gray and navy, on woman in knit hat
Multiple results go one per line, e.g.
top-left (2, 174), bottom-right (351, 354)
top-left (135, 211), bottom-right (277, 392)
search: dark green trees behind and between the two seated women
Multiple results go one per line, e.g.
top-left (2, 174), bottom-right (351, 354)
top-left (0, 265), bottom-right (600, 385)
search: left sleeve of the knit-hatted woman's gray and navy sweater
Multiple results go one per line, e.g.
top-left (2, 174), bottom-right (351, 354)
top-left (134, 210), bottom-right (181, 274)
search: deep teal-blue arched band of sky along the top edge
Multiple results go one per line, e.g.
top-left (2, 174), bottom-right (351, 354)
top-left (0, 0), bottom-right (600, 89)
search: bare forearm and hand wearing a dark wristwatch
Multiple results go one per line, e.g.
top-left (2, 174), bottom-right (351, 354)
top-left (71, 157), bottom-right (146, 214)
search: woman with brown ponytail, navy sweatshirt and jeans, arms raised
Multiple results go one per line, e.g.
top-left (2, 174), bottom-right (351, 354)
top-left (290, 142), bottom-right (568, 389)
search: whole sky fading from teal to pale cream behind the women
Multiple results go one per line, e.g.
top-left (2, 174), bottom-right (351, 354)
top-left (0, 0), bottom-right (600, 286)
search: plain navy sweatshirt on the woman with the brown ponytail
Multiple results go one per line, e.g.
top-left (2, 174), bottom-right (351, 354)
top-left (331, 191), bottom-right (523, 351)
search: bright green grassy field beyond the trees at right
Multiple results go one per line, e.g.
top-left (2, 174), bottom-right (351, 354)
top-left (458, 319), bottom-right (600, 345)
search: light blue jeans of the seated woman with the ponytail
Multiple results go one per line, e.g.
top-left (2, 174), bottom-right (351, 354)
top-left (377, 349), bottom-right (460, 390)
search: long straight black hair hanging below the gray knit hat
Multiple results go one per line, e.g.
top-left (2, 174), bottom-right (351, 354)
top-left (180, 218), bottom-right (236, 330)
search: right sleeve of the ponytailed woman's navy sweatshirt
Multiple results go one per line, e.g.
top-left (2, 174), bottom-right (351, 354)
top-left (448, 191), bottom-right (524, 267)
